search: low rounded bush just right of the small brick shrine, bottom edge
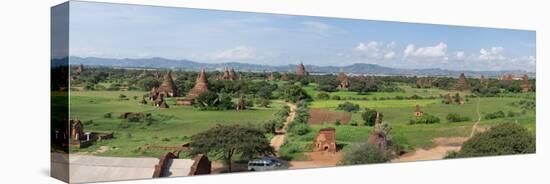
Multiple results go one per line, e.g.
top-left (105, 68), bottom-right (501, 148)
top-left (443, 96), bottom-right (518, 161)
top-left (339, 142), bottom-right (391, 165)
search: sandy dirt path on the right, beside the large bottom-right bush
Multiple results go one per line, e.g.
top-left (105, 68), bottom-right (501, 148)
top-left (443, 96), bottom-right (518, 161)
top-left (392, 97), bottom-right (484, 162)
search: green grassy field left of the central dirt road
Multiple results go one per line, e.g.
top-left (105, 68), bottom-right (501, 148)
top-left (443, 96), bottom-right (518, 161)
top-left (70, 91), bottom-right (281, 157)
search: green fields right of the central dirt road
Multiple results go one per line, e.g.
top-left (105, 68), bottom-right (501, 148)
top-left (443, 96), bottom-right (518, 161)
top-left (281, 86), bottom-right (536, 160)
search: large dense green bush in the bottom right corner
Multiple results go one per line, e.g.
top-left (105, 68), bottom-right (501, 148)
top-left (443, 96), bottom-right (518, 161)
top-left (447, 123), bottom-right (536, 158)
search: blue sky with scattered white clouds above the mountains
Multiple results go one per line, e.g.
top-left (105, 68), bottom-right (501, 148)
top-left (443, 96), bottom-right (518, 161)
top-left (69, 1), bottom-right (536, 72)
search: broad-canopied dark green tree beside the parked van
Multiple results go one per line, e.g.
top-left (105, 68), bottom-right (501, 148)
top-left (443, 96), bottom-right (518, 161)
top-left (189, 125), bottom-right (275, 172)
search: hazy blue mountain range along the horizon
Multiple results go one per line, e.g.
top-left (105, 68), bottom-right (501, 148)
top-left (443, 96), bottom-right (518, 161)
top-left (66, 56), bottom-right (535, 78)
